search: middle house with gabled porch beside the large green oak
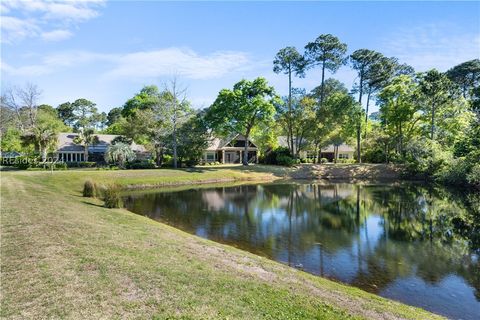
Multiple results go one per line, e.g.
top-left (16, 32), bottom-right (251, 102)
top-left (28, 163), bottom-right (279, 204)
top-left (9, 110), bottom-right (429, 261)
top-left (202, 134), bottom-right (258, 163)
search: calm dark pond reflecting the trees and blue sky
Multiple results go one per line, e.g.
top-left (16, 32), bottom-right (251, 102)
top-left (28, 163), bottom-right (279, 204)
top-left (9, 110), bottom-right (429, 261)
top-left (125, 183), bottom-right (480, 319)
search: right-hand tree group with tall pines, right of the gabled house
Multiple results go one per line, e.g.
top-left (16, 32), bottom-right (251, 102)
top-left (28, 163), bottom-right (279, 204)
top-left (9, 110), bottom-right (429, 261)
top-left (272, 34), bottom-right (480, 187)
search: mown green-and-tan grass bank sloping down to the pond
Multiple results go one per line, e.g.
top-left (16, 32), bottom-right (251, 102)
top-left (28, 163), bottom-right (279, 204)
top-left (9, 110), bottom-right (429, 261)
top-left (0, 167), bottom-right (442, 319)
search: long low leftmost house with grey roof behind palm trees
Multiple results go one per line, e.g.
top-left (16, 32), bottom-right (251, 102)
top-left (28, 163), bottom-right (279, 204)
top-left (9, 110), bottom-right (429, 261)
top-left (54, 133), bottom-right (151, 162)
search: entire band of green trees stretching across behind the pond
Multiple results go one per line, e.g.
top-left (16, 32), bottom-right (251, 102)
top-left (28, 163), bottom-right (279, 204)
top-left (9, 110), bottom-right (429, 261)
top-left (1, 34), bottom-right (480, 186)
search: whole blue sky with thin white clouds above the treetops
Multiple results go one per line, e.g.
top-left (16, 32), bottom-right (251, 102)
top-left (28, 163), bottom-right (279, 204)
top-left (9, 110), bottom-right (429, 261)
top-left (0, 0), bottom-right (480, 111)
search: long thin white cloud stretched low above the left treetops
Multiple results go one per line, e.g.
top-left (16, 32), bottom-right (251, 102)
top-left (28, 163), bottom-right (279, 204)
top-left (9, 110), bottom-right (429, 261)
top-left (2, 48), bottom-right (253, 80)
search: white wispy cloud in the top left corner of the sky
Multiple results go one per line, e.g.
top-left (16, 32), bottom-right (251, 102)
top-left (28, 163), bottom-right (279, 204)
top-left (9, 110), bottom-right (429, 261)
top-left (0, 0), bottom-right (105, 43)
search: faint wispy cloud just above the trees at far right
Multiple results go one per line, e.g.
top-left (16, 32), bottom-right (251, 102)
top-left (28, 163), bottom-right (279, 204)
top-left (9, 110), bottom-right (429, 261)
top-left (384, 24), bottom-right (480, 71)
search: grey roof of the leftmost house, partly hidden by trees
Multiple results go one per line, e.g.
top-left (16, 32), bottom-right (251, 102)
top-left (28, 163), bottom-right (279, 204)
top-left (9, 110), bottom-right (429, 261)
top-left (57, 132), bottom-right (146, 152)
